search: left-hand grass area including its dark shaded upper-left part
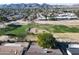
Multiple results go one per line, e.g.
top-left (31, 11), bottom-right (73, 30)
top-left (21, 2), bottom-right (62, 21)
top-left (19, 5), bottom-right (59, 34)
top-left (0, 25), bottom-right (29, 37)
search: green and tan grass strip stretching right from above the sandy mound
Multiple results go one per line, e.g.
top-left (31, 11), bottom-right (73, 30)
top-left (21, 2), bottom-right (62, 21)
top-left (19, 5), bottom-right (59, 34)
top-left (31, 24), bottom-right (79, 33)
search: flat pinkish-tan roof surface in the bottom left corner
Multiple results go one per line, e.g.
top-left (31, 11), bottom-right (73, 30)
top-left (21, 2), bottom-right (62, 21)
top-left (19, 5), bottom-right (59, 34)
top-left (0, 46), bottom-right (23, 55)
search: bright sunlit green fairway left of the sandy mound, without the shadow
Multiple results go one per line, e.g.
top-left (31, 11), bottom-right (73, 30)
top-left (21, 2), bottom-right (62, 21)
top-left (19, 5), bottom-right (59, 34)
top-left (7, 25), bottom-right (28, 37)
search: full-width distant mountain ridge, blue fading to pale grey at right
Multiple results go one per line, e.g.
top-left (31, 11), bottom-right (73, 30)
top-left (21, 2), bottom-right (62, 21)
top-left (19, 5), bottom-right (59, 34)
top-left (0, 3), bottom-right (79, 9)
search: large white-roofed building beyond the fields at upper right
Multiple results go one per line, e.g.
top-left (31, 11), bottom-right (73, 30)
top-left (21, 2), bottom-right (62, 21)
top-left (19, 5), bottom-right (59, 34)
top-left (54, 13), bottom-right (78, 20)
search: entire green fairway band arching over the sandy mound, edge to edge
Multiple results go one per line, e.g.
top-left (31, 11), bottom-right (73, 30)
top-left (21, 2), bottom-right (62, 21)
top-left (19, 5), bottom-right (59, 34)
top-left (0, 24), bottom-right (79, 37)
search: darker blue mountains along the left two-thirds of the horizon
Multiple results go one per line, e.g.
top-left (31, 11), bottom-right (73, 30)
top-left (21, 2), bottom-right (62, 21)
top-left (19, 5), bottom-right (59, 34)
top-left (0, 3), bottom-right (50, 9)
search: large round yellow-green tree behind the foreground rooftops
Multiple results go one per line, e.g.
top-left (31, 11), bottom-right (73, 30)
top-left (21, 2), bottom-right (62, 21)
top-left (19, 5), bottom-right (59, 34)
top-left (37, 33), bottom-right (55, 48)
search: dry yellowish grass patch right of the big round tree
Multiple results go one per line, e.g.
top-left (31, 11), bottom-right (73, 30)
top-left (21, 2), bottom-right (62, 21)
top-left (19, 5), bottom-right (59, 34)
top-left (53, 33), bottom-right (79, 42)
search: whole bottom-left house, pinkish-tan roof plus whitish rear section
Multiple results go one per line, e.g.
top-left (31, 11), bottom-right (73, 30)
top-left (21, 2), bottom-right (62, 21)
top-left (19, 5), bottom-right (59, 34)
top-left (0, 42), bottom-right (29, 55)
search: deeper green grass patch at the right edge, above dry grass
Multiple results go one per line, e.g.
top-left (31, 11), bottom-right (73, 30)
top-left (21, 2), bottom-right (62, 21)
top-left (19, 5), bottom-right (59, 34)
top-left (53, 25), bottom-right (79, 33)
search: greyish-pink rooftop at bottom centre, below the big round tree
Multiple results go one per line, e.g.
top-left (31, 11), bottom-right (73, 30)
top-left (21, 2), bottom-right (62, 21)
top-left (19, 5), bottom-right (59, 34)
top-left (26, 43), bottom-right (62, 55)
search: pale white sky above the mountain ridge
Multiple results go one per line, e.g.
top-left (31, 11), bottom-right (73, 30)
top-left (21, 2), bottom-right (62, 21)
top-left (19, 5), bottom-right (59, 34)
top-left (0, 0), bottom-right (79, 4)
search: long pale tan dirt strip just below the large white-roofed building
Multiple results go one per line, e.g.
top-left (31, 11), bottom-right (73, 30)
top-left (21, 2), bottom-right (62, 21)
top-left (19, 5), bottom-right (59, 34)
top-left (34, 20), bottom-right (79, 25)
